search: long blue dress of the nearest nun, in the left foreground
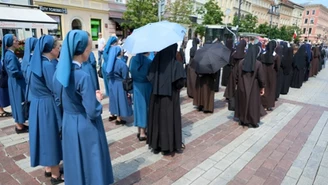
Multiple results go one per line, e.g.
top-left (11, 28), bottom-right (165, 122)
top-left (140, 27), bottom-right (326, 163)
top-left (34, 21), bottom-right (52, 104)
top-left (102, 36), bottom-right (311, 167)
top-left (54, 62), bottom-right (114, 185)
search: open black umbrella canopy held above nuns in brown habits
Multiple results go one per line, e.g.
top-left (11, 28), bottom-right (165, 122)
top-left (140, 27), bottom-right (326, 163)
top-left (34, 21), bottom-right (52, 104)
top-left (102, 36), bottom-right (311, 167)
top-left (190, 43), bottom-right (231, 74)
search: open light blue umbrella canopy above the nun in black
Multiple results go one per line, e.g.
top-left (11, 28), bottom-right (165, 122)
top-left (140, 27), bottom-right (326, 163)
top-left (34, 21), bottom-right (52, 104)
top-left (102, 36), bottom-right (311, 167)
top-left (123, 21), bottom-right (186, 54)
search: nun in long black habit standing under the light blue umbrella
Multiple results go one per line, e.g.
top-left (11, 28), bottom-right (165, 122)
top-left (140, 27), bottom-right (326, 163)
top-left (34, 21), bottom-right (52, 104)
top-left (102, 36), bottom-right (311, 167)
top-left (147, 44), bottom-right (186, 154)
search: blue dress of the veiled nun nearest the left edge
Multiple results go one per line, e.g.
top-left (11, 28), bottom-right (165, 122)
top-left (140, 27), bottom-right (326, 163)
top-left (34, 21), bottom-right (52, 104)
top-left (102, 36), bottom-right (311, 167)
top-left (4, 50), bottom-right (26, 124)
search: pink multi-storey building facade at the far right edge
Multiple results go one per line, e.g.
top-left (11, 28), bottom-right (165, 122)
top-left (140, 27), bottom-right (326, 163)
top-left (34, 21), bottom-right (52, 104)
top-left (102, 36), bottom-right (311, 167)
top-left (301, 4), bottom-right (328, 44)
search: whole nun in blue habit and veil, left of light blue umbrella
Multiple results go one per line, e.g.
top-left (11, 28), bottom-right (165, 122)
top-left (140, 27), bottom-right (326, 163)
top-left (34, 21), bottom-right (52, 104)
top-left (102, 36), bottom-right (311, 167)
top-left (106, 46), bottom-right (132, 125)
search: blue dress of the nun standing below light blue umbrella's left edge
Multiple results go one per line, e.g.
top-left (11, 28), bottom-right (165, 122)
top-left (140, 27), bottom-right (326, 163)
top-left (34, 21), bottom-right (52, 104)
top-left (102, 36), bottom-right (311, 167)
top-left (108, 56), bottom-right (132, 117)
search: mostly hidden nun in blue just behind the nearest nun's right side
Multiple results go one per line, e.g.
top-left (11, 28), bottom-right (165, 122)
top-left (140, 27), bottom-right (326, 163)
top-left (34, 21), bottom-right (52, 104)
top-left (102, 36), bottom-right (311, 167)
top-left (82, 52), bottom-right (100, 90)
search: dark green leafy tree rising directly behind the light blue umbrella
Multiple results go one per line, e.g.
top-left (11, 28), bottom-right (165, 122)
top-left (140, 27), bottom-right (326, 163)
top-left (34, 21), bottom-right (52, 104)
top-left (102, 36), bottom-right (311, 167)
top-left (123, 0), bottom-right (158, 28)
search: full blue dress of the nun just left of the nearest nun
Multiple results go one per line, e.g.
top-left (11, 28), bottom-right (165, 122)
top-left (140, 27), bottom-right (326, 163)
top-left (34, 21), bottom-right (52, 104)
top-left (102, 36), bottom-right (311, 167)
top-left (27, 57), bottom-right (62, 167)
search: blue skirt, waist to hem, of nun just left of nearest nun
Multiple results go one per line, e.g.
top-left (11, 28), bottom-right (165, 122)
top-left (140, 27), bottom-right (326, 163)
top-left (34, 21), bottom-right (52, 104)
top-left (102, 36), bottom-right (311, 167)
top-left (29, 97), bottom-right (63, 167)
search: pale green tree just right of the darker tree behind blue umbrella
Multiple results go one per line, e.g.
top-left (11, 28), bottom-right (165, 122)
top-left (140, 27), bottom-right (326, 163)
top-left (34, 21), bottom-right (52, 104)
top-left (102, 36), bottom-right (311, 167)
top-left (165, 0), bottom-right (194, 25)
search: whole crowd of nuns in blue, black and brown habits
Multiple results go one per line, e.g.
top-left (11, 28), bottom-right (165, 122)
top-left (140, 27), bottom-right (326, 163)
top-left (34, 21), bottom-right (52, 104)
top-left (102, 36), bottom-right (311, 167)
top-left (0, 30), bottom-right (328, 185)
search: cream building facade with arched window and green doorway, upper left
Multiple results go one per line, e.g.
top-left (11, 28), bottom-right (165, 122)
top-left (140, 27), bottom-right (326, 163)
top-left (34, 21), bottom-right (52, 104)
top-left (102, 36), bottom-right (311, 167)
top-left (34, 0), bottom-right (115, 48)
